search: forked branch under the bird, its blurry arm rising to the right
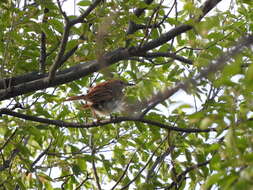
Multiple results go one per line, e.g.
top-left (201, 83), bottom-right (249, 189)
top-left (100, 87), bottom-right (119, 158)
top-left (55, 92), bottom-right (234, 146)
top-left (0, 32), bottom-right (250, 133)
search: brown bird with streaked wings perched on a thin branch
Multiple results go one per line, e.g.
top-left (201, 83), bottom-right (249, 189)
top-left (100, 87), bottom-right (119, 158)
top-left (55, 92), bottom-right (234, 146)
top-left (66, 79), bottom-right (134, 118)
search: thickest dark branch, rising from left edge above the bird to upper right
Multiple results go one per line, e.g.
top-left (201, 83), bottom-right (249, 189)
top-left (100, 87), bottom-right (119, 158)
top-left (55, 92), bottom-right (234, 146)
top-left (0, 0), bottom-right (221, 100)
